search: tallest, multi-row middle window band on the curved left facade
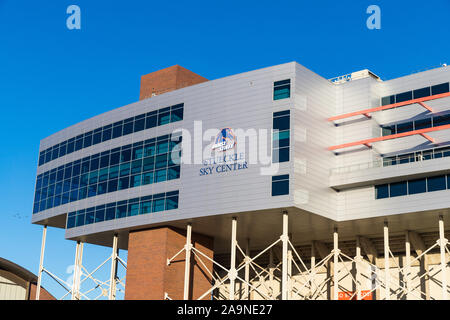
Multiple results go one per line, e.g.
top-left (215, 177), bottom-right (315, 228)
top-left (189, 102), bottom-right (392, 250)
top-left (33, 135), bottom-right (181, 213)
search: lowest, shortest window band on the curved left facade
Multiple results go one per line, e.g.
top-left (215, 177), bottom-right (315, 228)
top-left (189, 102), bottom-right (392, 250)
top-left (66, 191), bottom-right (179, 229)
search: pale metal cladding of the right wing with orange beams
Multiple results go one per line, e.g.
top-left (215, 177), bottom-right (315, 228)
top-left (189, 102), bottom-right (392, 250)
top-left (338, 67), bottom-right (450, 221)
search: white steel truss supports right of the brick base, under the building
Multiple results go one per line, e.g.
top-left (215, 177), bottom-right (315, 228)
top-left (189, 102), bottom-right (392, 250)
top-left (165, 211), bottom-right (450, 300)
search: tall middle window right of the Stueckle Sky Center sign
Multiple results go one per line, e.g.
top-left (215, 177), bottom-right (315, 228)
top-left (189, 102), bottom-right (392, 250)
top-left (272, 110), bottom-right (290, 163)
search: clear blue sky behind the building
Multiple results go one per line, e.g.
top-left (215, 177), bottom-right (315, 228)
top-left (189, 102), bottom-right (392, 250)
top-left (0, 0), bottom-right (450, 296)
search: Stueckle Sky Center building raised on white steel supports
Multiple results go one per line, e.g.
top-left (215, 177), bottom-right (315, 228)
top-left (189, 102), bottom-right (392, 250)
top-left (32, 62), bottom-right (450, 300)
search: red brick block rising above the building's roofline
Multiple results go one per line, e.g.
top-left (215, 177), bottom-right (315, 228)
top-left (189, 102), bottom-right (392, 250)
top-left (139, 65), bottom-right (208, 100)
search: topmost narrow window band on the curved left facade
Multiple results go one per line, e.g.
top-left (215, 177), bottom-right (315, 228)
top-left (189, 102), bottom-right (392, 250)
top-left (39, 103), bottom-right (184, 166)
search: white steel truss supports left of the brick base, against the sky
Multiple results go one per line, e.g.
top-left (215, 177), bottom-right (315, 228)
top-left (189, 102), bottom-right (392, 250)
top-left (35, 226), bottom-right (127, 300)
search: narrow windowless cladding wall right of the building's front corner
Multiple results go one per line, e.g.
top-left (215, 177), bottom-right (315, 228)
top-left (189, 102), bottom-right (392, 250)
top-left (292, 64), bottom-right (336, 219)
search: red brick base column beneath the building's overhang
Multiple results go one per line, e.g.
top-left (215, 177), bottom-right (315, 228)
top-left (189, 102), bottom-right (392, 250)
top-left (125, 227), bottom-right (213, 300)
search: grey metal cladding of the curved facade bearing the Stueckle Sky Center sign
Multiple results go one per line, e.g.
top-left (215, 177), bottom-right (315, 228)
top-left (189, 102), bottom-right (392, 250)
top-left (32, 63), bottom-right (302, 234)
